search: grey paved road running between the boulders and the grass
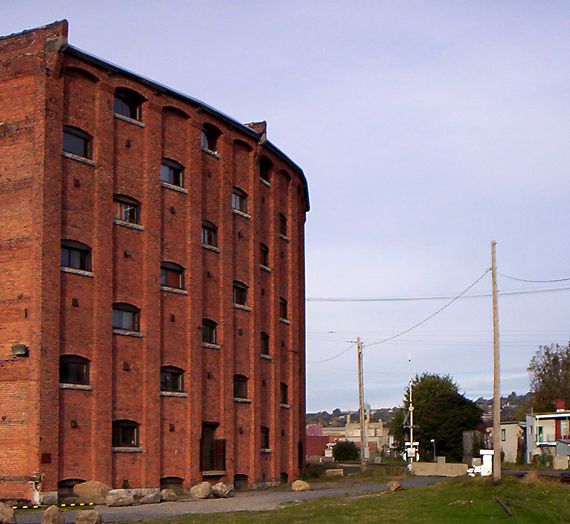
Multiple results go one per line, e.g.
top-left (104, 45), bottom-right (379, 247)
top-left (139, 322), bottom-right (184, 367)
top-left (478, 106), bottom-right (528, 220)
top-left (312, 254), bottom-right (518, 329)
top-left (16, 477), bottom-right (442, 524)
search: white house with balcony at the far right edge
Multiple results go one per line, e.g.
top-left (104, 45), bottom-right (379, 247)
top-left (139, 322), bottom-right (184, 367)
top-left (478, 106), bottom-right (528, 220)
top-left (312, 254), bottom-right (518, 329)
top-left (526, 400), bottom-right (570, 464)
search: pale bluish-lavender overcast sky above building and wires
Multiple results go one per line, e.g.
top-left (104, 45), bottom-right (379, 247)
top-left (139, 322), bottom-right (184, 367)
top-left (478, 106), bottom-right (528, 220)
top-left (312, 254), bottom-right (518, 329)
top-left (5, 0), bottom-right (570, 411)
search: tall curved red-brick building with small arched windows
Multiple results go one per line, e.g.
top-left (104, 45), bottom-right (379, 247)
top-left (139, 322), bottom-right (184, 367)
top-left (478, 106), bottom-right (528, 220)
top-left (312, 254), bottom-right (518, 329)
top-left (0, 21), bottom-right (309, 504)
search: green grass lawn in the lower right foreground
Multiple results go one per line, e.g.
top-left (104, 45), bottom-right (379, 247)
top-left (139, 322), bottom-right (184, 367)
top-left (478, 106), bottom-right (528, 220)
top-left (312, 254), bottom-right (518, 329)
top-left (138, 478), bottom-right (570, 524)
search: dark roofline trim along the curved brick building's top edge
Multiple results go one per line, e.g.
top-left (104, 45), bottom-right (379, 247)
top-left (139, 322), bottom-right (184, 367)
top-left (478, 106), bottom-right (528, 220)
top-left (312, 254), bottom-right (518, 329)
top-left (61, 44), bottom-right (310, 211)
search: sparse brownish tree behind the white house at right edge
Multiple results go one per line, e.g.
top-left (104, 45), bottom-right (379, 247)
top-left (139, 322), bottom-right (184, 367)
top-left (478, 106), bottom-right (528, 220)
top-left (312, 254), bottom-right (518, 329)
top-left (528, 343), bottom-right (570, 411)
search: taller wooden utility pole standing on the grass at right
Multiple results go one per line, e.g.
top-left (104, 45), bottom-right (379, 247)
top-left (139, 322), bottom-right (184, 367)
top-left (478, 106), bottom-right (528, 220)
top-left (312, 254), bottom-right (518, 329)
top-left (491, 240), bottom-right (501, 482)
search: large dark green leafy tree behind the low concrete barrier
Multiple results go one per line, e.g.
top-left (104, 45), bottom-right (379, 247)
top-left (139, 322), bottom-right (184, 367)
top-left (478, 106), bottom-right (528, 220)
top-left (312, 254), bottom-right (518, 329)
top-left (392, 373), bottom-right (482, 460)
